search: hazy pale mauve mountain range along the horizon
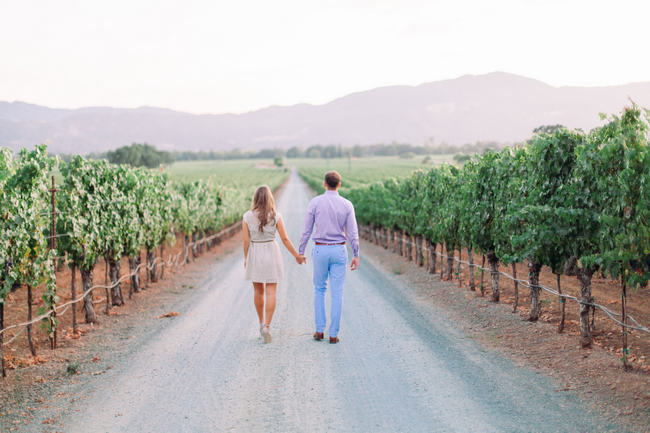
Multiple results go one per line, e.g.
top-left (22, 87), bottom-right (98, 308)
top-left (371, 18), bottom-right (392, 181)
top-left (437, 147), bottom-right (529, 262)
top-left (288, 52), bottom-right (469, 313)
top-left (0, 72), bottom-right (650, 154)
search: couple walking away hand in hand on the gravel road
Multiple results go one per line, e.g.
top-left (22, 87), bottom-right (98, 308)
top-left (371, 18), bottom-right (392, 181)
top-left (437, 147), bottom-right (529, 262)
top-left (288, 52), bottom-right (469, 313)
top-left (242, 171), bottom-right (359, 343)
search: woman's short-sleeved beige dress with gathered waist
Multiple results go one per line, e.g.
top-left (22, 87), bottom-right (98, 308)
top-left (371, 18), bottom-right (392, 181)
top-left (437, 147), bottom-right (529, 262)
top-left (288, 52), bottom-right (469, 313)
top-left (244, 210), bottom-right (284, 283)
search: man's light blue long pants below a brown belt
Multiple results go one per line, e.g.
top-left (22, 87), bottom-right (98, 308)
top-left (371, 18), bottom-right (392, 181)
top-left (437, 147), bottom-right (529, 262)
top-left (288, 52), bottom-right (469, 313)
top-left (311, 245), bottom-right (348, 337)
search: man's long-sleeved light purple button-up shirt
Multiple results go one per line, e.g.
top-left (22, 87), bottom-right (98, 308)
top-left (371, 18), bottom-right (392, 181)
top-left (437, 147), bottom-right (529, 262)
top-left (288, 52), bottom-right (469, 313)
top-left (298, 190), bottom-right (359, 257)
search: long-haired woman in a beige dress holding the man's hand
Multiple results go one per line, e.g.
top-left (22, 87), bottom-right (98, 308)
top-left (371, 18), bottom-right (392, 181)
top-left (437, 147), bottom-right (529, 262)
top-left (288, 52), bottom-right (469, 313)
top-left (242, 185), bottom-right (305, 343)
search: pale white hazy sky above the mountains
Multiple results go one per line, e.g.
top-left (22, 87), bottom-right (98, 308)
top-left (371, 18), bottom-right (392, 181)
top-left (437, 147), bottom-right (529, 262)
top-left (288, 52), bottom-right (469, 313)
top-left (0, 0), bottom-right (650, 113)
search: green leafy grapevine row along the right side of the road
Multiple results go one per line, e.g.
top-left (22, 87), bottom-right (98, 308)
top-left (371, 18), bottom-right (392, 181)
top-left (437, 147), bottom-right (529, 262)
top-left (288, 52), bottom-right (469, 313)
top-left (305, 105), bottom-right (650, 368)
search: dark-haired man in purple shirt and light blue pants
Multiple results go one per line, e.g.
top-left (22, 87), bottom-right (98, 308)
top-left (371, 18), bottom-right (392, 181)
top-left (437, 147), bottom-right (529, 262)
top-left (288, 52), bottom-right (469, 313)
top-left (298, 171), bottom-right (359, 344)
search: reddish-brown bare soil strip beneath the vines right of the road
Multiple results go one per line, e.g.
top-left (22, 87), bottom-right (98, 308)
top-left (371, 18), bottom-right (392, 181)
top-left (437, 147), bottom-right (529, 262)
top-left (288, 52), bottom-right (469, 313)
top-left (361, 241), bottom-right (650, 432)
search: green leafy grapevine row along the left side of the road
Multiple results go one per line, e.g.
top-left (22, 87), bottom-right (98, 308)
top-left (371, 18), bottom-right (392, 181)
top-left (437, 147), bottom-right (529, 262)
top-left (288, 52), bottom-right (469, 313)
top-left (0, 145), bottom-right (286, 377)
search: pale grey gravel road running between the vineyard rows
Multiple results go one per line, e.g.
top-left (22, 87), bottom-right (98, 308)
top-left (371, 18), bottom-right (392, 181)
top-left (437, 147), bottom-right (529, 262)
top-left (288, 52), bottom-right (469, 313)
top-left (59, 173), bottom-right (614, 432)
